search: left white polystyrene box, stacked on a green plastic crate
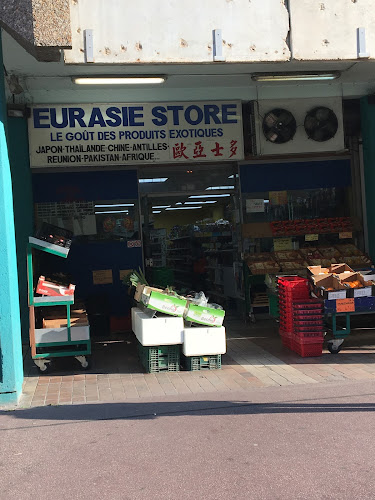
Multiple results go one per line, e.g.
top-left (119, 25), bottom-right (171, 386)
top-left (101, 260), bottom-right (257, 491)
top-left (132, 308), bottom-right (184, 346)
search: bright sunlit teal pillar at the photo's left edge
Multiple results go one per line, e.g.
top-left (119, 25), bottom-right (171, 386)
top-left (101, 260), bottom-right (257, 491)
top-left (0, 32), bottom-right (23, 405)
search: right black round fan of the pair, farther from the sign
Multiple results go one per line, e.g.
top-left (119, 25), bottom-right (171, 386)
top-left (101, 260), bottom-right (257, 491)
top-left (304, 107), bottom-right (339, 142)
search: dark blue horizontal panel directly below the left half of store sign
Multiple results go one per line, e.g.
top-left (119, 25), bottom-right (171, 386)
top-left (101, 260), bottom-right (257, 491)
top-left (33, 170), bottom-right (138, 199)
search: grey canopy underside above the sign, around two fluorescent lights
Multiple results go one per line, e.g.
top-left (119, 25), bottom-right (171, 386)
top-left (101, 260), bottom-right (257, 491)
top-left (3, 31), bottom-right (375, 103)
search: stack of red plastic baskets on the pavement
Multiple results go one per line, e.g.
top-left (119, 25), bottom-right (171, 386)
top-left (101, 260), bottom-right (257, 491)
top-left (278, 276), bottom-right (324, 357)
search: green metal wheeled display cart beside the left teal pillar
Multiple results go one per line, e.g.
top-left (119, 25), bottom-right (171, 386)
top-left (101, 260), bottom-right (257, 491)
top-left (27, 237), bottom-right (91, 373)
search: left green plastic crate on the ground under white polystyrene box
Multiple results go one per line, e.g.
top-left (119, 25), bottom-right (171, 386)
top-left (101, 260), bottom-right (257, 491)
top-left (138, 343), bottom-right (180, 373)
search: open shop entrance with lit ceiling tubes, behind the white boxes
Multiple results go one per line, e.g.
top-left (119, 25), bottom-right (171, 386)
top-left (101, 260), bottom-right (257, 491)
top-left (139, 165), bottom-right (242, 311)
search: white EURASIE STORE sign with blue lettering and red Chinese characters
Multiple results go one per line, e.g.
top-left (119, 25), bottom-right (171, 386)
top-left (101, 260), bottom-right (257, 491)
top-left (29, 101), bottom-right (243, 167)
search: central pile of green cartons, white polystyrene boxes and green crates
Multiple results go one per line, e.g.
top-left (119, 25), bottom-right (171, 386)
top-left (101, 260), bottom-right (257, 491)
top-left (132, 284), bottom-right (226, 372)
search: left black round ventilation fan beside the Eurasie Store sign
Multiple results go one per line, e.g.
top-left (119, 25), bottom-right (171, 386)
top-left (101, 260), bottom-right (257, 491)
top-left (262, 108), bottom-right (297, 144)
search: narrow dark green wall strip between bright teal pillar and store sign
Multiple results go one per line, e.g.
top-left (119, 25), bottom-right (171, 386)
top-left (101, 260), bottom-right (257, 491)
top-left (8, 118), bottom-right (33, 343)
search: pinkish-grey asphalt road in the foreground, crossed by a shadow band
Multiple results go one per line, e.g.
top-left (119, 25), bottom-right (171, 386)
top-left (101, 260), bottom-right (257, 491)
top-left (0, 382), bottom-right (375, 500)
